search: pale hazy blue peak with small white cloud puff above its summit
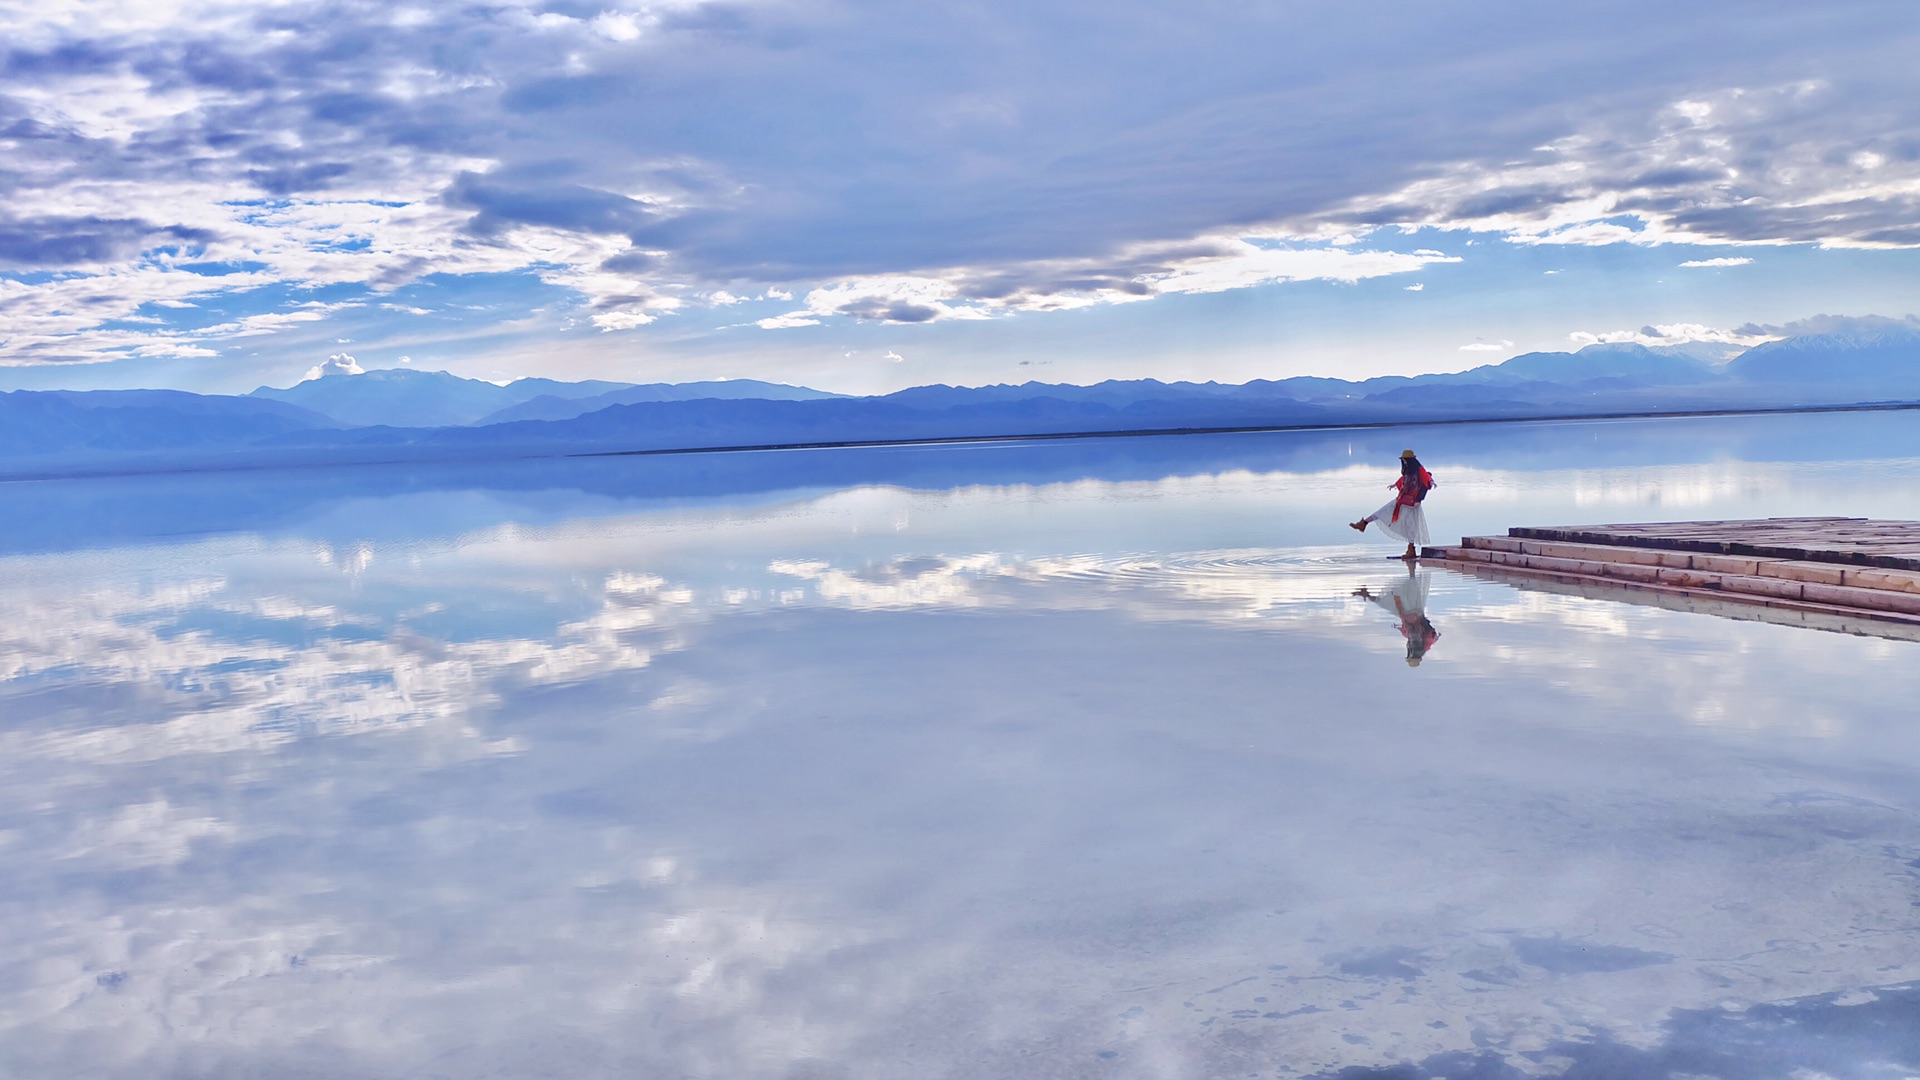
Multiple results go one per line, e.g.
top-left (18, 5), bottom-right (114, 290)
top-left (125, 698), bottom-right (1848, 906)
top-left (250, 367), bottom-right (628, 427)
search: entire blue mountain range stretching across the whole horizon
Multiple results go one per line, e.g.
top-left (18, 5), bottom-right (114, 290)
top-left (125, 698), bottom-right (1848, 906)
top-left (0, 321), bottom-right (1920, 466)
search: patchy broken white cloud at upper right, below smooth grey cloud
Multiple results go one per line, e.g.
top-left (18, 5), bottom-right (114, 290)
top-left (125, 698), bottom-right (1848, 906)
top-left (1321, 79), bottom-right (1920, 249)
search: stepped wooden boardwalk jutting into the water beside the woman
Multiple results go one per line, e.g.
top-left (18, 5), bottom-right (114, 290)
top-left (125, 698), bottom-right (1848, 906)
top-left (1425, 517), bottom-right (1920, 640)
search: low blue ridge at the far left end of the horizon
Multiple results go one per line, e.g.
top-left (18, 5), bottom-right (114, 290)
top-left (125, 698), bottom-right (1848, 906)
top-left (0, 390), bottom-right (338, 457)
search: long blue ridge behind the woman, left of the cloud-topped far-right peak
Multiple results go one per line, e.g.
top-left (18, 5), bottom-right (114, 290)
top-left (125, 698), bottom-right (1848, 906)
top-left (247, 334), bottom-right (1896, 450)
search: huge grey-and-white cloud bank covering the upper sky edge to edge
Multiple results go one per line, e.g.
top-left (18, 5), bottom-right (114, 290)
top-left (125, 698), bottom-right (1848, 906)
top-left (0, 0), bottom-right (1920, 363)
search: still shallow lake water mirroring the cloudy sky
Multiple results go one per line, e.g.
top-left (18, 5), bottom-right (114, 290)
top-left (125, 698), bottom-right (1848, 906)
top-left (11, 413), bottom-right (1920, 1080)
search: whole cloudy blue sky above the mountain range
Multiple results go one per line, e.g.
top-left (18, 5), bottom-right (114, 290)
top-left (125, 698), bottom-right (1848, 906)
top-left (0, 0), bottom-right (1920, 392)
